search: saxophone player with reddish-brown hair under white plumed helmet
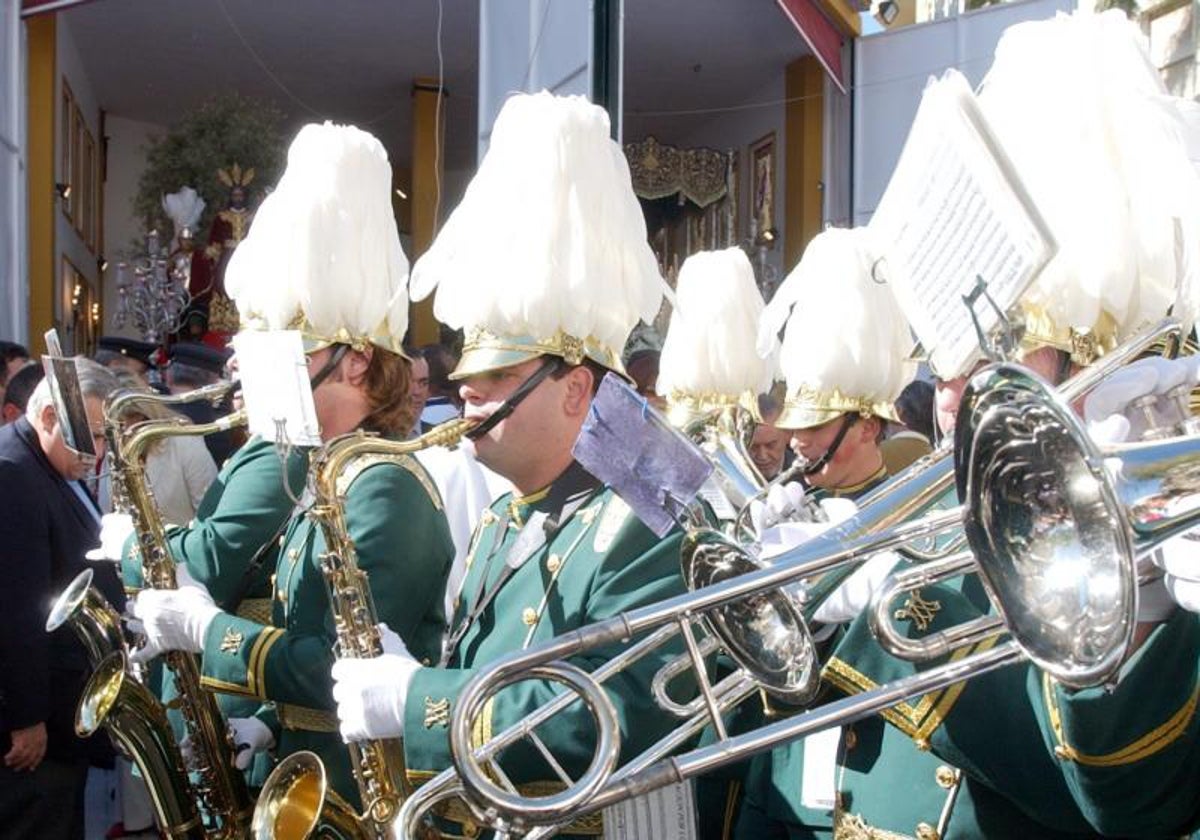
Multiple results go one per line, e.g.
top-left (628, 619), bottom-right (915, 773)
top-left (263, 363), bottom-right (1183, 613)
top-left (126, 122), bottom-right (454, 803)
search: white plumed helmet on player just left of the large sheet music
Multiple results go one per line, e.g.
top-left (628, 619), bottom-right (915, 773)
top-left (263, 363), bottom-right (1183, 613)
top-left (758, 228), bottom-right (916, 428)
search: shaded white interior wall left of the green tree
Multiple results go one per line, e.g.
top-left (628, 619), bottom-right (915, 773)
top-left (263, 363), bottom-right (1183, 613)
top-left (101, 114), bottom-right (166, 338)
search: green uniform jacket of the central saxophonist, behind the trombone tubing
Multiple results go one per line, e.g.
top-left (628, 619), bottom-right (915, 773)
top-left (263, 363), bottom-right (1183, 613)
top-left (404, 464), bottom-right (684, 834)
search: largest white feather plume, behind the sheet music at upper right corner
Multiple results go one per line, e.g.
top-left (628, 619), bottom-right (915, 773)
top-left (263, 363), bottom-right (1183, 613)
top-left (979, 11), bottom-right (1200, 338)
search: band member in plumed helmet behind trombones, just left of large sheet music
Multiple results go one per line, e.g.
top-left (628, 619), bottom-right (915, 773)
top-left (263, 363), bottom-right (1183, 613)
top-left (731, 229), bottom-right (912, 838)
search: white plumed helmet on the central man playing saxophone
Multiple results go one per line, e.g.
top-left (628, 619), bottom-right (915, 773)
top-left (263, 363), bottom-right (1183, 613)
top-left (412, 91), bottom-right (667, 378)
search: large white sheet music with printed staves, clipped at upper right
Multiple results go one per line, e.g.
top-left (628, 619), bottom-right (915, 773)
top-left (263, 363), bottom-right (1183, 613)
top-left (869, 70), bottom-right (1056, 378)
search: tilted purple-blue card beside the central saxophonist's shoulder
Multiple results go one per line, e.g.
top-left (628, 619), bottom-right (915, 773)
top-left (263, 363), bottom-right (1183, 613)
top-left (571, 373), bottom-right (713, 536)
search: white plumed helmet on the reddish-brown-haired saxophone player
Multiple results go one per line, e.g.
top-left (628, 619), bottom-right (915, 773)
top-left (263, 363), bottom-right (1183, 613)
top-left (226, 122), bottom-right (408, 353)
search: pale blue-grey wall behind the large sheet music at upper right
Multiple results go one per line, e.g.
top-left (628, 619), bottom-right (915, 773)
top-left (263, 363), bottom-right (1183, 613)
top-left (851, 0), bottom-right (1075, 224)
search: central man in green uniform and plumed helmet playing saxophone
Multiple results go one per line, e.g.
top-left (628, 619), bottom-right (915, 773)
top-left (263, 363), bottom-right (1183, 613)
top-left (334, 92), bottom-right (683, 836)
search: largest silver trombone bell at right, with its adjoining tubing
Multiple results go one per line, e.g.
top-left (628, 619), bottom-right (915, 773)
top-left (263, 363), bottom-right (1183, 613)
top-left (868, 365), bottom-right (1200, 688)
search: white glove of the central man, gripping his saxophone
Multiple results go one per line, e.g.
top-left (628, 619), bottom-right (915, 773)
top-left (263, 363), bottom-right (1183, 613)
top-left (332, 624), bottom-right (421, 744)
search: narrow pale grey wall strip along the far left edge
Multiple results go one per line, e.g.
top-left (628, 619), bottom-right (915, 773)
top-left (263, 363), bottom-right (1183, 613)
top-left (0, 2), bottom-right (29, 347)
